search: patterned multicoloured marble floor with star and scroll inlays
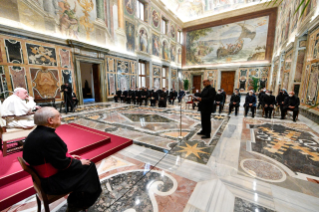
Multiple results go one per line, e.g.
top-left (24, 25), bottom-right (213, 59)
top-left (5, 98), bottom-right (319, 212)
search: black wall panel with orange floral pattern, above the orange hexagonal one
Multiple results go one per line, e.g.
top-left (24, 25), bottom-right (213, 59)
top-left (26, 43), bottom-right (57, 66)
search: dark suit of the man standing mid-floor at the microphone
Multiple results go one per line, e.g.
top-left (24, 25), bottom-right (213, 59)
top-left (198, 85), bottom-right (216, 137)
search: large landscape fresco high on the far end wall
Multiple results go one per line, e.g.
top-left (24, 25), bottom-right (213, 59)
top-left (186, 16), bottom-right (269, 65)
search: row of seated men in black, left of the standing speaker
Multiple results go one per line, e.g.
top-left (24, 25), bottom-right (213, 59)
top-left (114, 88), bottom-right (185, 107)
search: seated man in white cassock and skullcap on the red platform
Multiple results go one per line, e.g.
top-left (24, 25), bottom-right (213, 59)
top-left (1, 88), bottom-right (40, 128)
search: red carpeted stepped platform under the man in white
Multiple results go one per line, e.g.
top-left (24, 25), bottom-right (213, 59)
top-left (0, 124), bottom-right (133, 210)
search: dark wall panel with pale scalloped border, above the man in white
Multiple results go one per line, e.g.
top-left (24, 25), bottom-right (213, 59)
top-left (5, 39), bottom-right (23, 64)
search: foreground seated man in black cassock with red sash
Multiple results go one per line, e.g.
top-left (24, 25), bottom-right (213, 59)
top-left (23, 107), bottom-right (102, 211)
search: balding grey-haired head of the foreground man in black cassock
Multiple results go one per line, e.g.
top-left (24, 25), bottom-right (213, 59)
top-left (34, 107), bottom-right (61, 128)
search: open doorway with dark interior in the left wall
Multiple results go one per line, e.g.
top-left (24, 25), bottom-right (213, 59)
top-left (80, 62), bottom-right (101, 104)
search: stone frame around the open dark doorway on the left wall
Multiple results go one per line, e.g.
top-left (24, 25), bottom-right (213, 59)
top-left (74, 55), bottom-right (107, 105)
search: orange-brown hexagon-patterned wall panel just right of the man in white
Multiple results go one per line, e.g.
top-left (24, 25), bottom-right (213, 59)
top-left (30, 68), bottom-right (61, 99)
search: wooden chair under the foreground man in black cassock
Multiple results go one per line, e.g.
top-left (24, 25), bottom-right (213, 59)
top-left (18, 157), bottom-right (70, 212)
